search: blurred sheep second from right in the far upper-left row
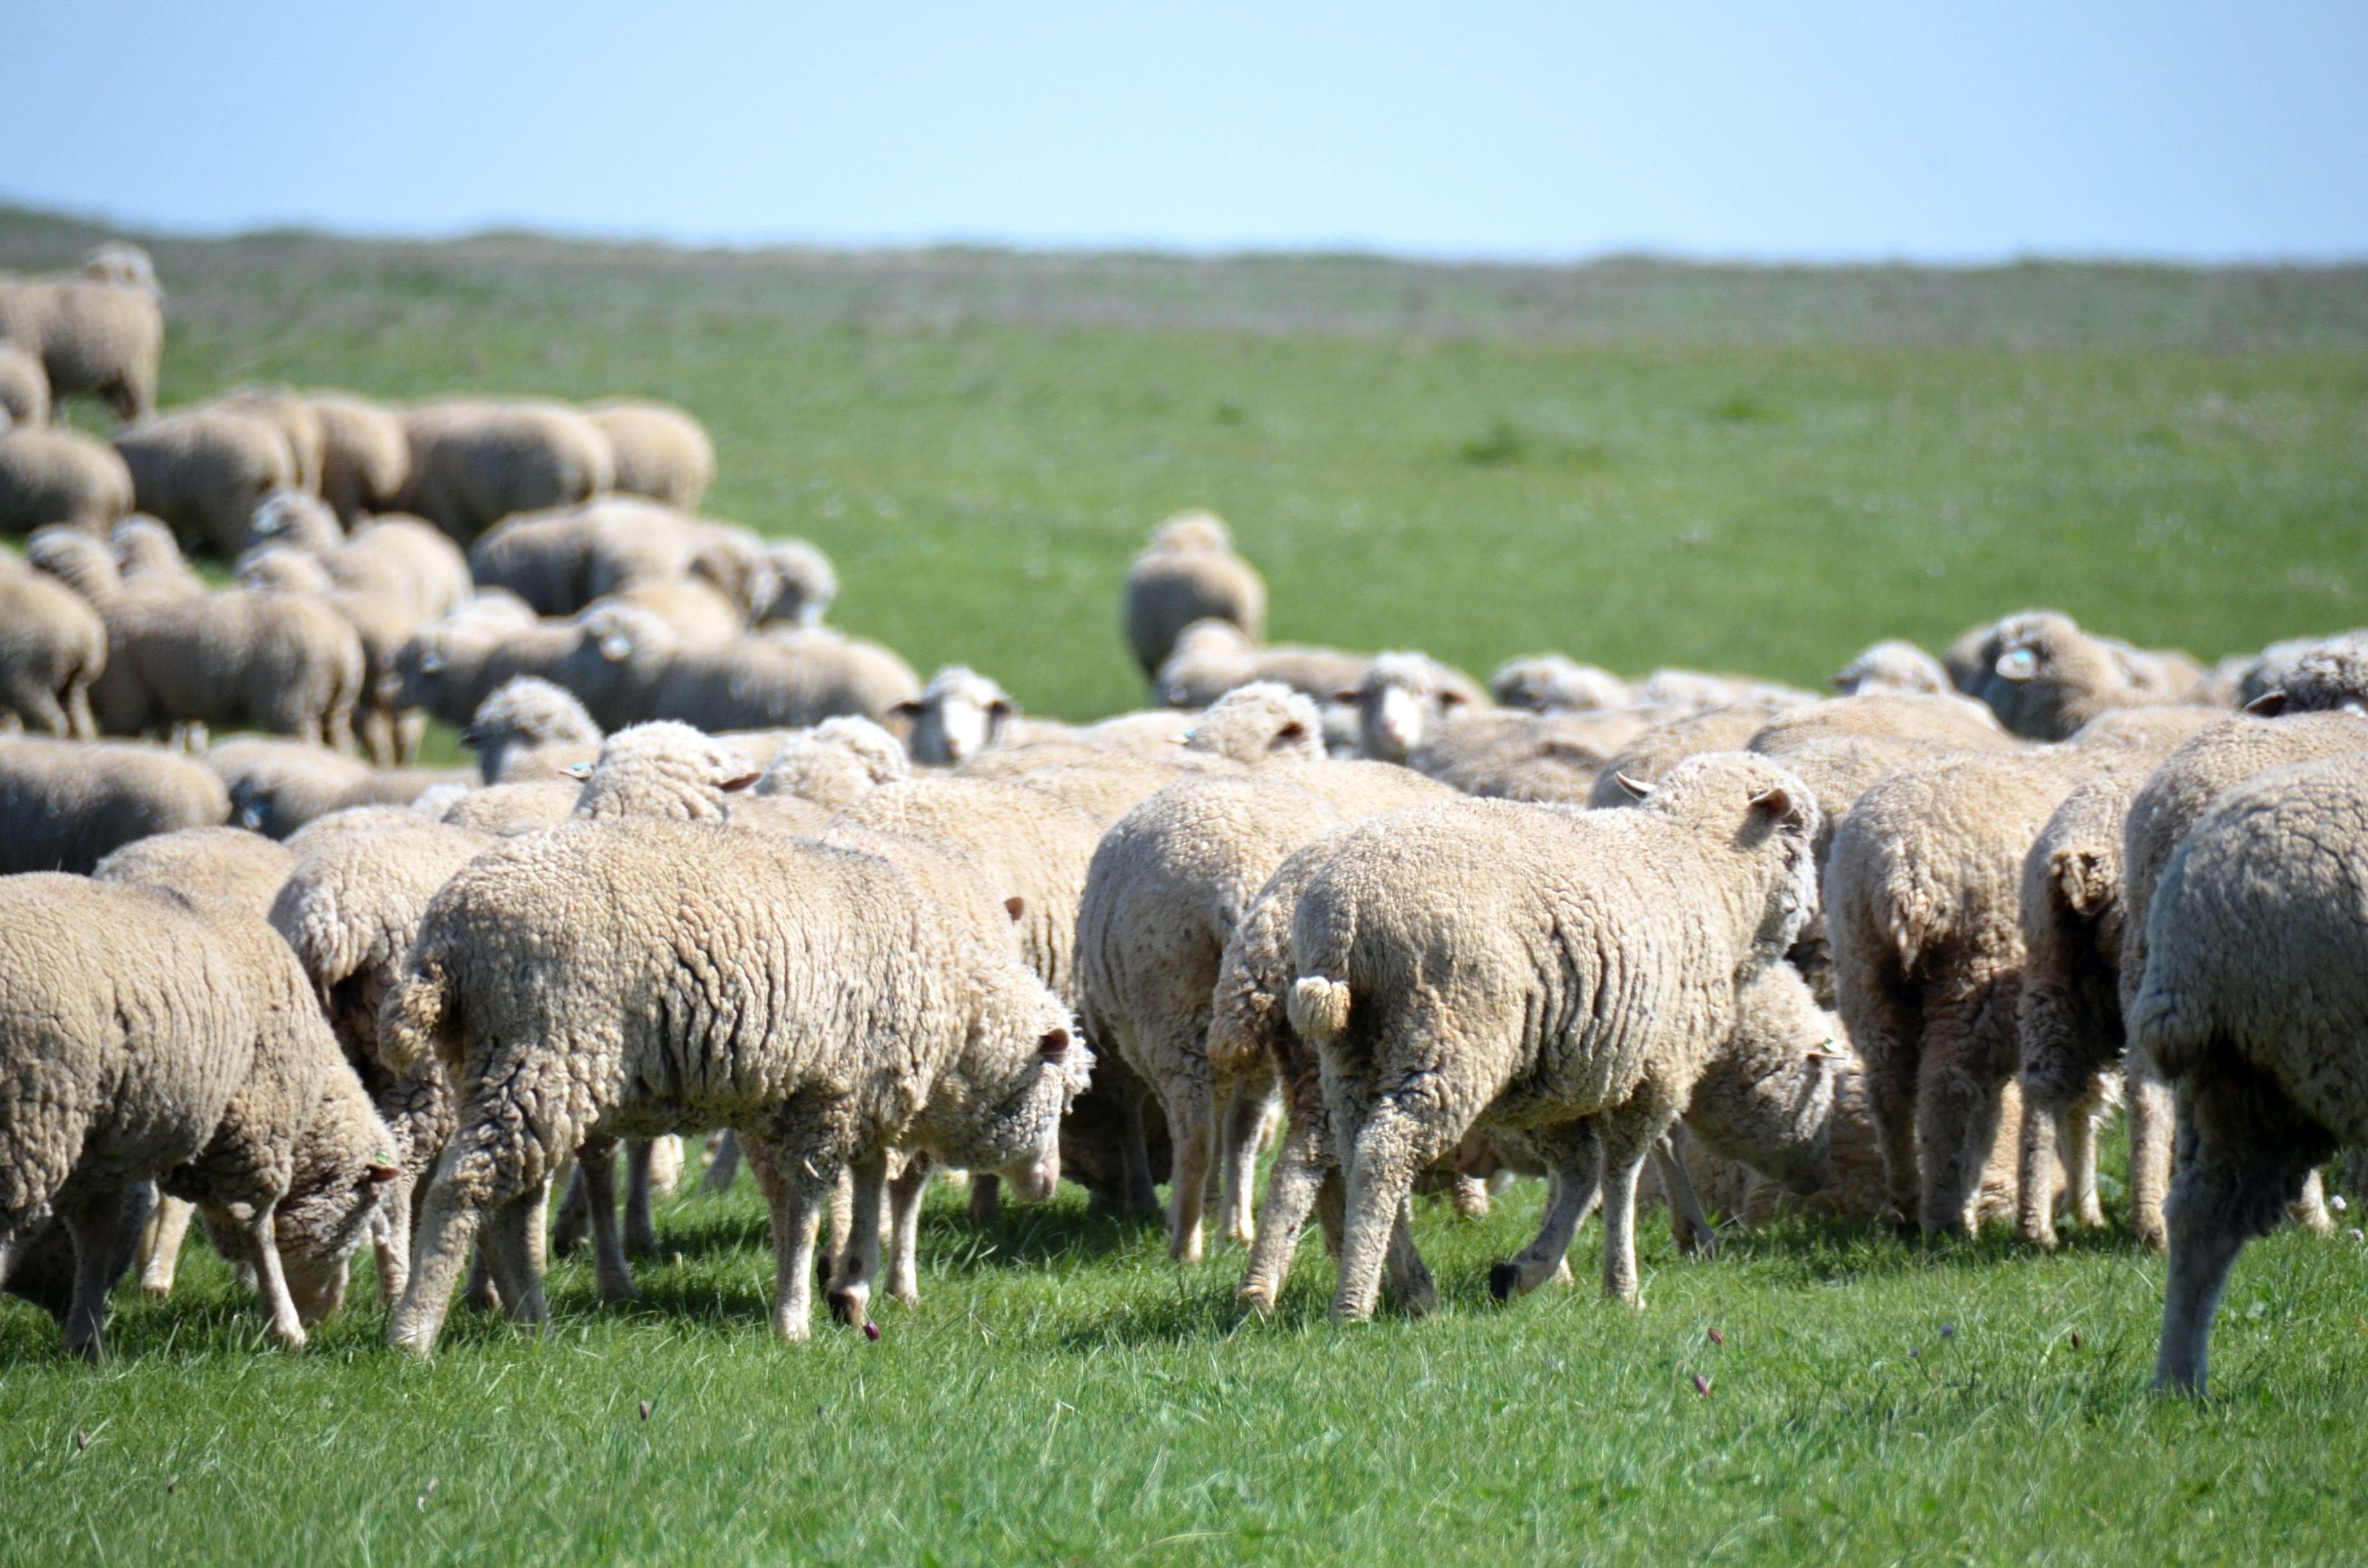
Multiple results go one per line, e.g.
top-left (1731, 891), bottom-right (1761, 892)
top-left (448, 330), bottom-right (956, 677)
top-left (395, 398), bottom-right (616, 545)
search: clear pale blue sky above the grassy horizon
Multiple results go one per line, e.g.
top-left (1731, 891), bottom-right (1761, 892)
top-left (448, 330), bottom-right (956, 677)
top-left (0, 0), bottom-right (2368, 261)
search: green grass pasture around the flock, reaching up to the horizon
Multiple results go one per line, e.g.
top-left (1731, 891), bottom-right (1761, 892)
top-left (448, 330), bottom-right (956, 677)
top-left (13, 213), bottom-right (2368, 1564)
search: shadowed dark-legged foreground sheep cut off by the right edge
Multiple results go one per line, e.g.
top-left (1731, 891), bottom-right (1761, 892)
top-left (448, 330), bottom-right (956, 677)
top-left (2124, 751), bottom-right (2368, 1392)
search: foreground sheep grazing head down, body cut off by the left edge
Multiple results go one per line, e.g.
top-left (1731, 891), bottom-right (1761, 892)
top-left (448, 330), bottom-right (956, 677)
top-left (0, 874), bottom-right (393, 1355)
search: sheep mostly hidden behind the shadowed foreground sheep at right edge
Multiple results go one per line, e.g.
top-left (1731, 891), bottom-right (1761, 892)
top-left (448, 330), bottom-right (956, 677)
top-left (2117, 705), bottom-right (2368, 1250)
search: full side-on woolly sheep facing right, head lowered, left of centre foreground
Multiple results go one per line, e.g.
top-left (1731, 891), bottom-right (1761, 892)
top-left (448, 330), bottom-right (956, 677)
top-left (379, 739), bottom-right (1089, 1355)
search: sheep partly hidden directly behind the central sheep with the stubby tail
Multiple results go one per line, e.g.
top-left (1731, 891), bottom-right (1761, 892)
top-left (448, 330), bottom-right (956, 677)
top-left (1078, 758), bottom-right (1447, 1262)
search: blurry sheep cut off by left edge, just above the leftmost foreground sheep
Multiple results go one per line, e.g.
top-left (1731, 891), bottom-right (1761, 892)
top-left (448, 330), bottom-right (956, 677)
top-left (0, 737), bottom-right (230, 874)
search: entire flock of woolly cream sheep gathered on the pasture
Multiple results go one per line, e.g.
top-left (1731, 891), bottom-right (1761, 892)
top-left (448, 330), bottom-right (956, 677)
top-left (0, 247), bottom-right (2368, 1391)
